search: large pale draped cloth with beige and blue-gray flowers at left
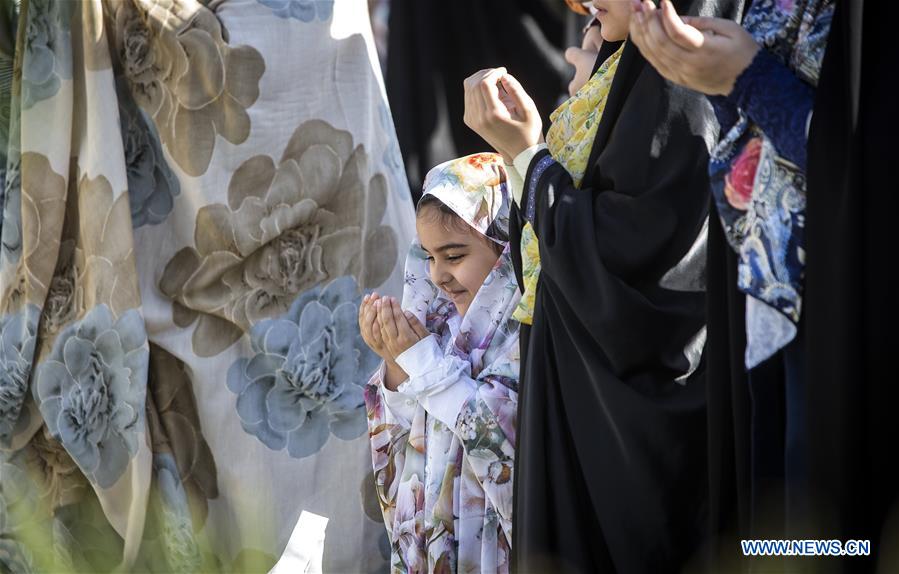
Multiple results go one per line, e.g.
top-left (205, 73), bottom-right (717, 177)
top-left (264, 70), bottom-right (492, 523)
top-left (0, 0), bottom-right (413, 574)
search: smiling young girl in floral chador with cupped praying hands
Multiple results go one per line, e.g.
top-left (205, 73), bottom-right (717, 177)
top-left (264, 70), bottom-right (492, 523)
top-left (359, 154), bottom-right (520, 572)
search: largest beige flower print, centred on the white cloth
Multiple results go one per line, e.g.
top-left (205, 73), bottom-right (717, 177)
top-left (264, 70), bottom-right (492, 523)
top-left (159, 120), bottom-right (397, 357)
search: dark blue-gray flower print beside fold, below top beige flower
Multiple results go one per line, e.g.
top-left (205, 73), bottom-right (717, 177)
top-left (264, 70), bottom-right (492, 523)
top-left (116, 78), bottom-right (181, 229)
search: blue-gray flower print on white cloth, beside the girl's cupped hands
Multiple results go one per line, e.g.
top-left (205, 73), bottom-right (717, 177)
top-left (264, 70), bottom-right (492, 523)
top-left (228, 276), bottom-right (378, 458)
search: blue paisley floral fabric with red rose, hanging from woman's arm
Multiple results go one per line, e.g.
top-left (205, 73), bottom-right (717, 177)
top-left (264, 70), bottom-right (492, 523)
top-left (709, 0), bottom-right (834, 368)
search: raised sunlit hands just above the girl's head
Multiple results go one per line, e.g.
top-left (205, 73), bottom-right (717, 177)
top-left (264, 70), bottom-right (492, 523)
top-left (464, 68), bottom-right (543, 163)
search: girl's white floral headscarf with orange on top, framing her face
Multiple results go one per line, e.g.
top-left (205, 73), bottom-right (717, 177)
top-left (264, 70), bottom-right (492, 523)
top-left (402, 153), bottom-right (520, 378)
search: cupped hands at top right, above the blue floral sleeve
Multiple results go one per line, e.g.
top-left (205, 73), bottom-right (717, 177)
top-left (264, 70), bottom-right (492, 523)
top-left (630, 0), bottom-right (761, 95)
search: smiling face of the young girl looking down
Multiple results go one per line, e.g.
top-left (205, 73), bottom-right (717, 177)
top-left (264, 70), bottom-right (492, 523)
top-left (415, 207), bottom-right (499, 316)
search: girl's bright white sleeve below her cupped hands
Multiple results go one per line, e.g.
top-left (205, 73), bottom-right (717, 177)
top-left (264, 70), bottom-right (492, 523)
top-left (396, 335), bottom-right (477, 429)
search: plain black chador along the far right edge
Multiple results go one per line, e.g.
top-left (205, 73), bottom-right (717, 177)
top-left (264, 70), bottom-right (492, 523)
top-left (804, 0), bottom-right (899, 572)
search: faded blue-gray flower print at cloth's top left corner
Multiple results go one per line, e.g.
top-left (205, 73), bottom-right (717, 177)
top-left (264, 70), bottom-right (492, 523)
top-left (22, 0), bottom-right (76, 109)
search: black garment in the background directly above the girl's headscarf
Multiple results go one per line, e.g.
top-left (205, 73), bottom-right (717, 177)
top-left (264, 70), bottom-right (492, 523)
top-left (386, 0), bottom-right (579, 200)
